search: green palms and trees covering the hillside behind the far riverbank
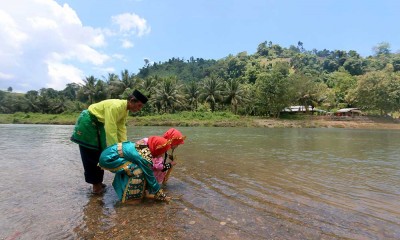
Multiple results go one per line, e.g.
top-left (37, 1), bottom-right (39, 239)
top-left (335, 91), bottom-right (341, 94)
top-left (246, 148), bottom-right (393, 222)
top-left (0, 41), bottom-right (400, 117)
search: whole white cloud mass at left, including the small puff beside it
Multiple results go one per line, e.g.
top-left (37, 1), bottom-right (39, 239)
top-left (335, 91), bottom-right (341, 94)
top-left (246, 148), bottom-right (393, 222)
top-left (0, 0), bottom-right (150, 92)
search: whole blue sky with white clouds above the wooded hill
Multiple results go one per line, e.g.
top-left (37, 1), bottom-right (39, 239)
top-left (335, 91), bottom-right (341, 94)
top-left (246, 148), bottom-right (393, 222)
top-left (0, 0), bottom-right (400, 93)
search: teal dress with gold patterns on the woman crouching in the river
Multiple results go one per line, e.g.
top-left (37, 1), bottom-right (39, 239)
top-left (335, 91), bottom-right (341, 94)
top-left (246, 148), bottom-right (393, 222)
top-left (99, 141), bottom-right (160, 202)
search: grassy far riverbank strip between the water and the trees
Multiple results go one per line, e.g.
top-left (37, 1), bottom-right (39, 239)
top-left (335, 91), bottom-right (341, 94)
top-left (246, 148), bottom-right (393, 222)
top-left (0, 112), bottom-right (400, 129)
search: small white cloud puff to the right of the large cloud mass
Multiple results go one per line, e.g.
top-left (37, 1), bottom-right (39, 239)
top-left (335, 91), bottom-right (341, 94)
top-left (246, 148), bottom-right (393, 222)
top-left (112, 13), bottom-right (151, 37)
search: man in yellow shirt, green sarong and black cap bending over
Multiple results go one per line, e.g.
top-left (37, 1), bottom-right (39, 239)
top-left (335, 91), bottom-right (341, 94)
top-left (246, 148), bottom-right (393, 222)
top-left (71, 90), bottom-right (148, 194)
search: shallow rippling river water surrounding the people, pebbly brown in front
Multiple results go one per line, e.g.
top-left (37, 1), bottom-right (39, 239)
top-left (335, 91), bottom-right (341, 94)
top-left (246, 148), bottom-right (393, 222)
top-left (0, 125), bottom-right (400, 239)
